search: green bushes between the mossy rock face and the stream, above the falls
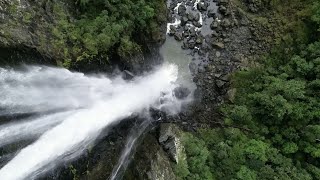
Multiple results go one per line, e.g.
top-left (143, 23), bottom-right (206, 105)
top-left (53, 0), bottom-right (164, 66)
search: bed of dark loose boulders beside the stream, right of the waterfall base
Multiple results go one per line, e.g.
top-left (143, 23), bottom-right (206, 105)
top-left (161, 0), bottom-right (269, 128)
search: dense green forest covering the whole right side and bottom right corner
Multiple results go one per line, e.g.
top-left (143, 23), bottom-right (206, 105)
top-left (176, 2), bottom-right (320, 180)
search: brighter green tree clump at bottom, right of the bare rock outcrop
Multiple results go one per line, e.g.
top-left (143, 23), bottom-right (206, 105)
top-left (180, 128), bottom-right (319, 180)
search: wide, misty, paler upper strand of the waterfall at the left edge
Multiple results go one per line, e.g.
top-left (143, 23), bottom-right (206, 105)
top-left (0, 66), bottom-right (115, 116)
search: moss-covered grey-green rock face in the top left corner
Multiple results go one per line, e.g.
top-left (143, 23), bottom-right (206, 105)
top-left (0, 0), bottom-right (73, 65)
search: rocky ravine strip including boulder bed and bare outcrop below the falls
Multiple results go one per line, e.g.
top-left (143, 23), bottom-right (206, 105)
top-left (124, 0), bottom-right (269, 180)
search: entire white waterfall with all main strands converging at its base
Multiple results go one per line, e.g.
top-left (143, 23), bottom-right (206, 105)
top-left (0, 65), bottom-right (177, 180)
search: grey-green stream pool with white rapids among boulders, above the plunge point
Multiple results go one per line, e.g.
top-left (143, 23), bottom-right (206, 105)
top-left (164, 0), bottom-right (218, 91)
